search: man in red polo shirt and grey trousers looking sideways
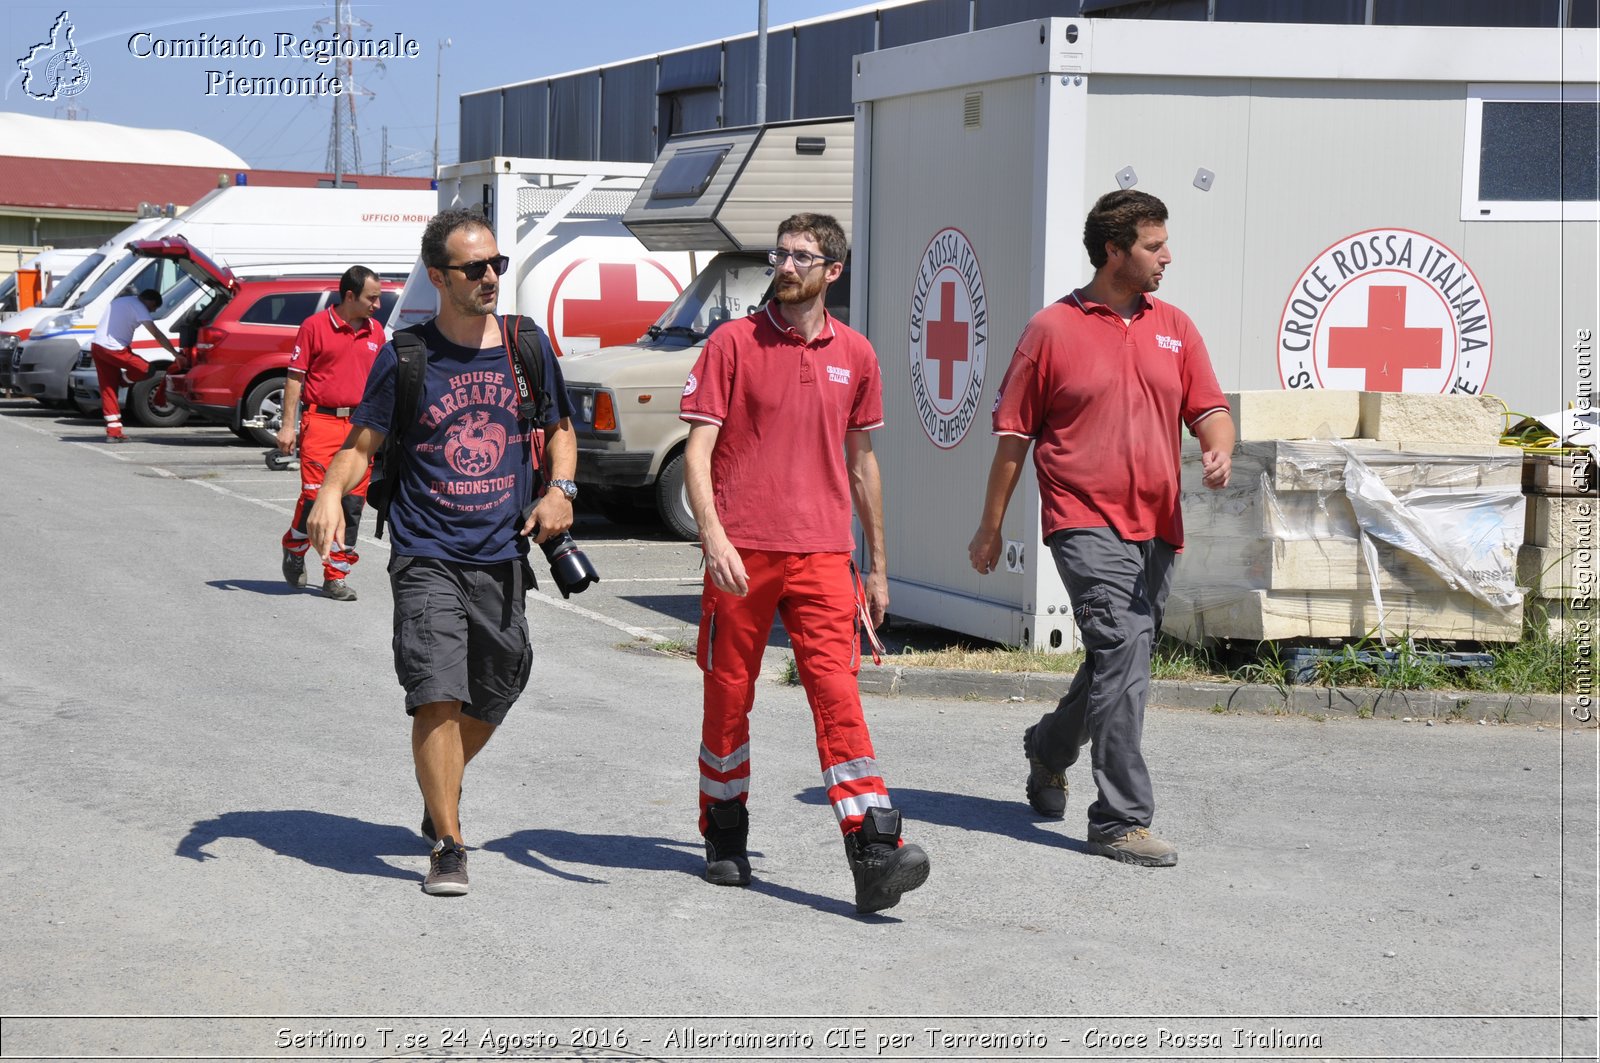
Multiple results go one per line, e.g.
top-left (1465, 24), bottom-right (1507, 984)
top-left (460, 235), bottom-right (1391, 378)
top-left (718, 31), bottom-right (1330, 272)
top-left (968, 191), bottom-right (1234, 868)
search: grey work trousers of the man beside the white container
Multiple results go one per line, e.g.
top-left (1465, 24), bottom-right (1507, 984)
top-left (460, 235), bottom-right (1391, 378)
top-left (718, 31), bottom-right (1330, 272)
top-left (1034, 528), bottom-right (1178, 837)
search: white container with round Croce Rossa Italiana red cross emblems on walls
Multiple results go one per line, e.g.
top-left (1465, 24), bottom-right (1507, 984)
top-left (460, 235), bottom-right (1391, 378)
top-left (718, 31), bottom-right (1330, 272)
top-left (853, 19), bottom-right (1600, 650)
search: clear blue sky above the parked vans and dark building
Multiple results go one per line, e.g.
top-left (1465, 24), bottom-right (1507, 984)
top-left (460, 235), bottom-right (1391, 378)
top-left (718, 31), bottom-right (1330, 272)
top-left (0, 0), bottom-right (864, 179)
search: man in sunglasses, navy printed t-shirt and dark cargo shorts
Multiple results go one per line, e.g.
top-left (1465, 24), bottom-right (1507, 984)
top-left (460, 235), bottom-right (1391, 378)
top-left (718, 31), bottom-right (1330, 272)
top-left (310, 210), bottom-right (578, 897)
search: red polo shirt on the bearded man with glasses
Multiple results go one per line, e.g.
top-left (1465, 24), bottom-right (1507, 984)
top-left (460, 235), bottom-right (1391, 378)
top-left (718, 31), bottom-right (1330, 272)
top-left (678, 303), bottom-right (883, 554)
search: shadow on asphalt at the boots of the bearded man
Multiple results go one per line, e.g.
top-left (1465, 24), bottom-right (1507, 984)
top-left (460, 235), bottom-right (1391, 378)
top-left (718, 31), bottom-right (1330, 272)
top-left (480, 829), bottom-right (878, 919)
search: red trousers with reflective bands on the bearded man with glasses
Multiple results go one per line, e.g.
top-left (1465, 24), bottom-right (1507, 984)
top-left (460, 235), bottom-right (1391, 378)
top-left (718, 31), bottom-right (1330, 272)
top-left (698, 549), bottom-right (890, 834)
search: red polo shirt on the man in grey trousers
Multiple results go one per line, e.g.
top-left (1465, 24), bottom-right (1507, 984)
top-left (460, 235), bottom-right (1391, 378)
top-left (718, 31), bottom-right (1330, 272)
top-left (994, 291), bottom-right (1227, 548)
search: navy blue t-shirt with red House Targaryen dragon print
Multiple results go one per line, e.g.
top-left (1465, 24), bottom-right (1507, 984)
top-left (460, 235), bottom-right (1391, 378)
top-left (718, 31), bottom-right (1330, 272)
top-left (350, 320), bottom-right (573, 565)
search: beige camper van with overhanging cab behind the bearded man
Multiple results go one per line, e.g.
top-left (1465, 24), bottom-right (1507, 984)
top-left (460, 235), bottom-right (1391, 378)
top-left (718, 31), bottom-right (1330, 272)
top-left (563, 118), bottom-right (854, 540)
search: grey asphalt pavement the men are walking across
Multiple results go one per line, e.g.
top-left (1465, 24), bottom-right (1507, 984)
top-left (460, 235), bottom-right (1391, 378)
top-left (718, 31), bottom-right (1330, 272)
top-left (0, 400), bottom-right (1597, 1060)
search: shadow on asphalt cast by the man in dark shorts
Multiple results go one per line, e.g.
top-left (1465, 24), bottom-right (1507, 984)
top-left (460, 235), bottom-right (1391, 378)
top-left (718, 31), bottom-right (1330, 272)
top-left (174, 808), bottom-right (427, 882)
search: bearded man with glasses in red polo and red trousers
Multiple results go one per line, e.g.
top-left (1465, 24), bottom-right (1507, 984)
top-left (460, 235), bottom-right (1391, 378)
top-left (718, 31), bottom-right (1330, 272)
top-left (680, 215), bottom-right (928, 913)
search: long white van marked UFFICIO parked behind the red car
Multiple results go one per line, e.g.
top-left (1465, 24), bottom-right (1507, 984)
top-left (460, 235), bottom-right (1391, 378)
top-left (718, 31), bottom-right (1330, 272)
top-left (11, 186), bottom-right (434, 423)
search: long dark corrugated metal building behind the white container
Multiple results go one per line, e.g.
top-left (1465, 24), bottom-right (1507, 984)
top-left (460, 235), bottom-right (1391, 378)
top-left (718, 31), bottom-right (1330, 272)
top-left (458, 0), bottom-right (1600, 162)
